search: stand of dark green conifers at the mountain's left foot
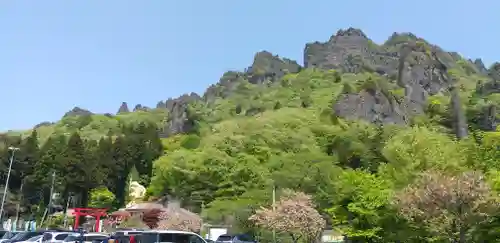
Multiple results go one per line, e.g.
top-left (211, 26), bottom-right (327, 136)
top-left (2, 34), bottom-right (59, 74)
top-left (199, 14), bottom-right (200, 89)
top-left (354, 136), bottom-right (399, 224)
top-left (1, 123), bottom-right (163, 217)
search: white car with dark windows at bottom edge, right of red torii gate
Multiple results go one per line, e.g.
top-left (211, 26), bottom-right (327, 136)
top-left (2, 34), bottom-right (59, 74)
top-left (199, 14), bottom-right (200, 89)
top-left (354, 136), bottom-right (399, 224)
top-left (137, 230), bottom-right (207, 243)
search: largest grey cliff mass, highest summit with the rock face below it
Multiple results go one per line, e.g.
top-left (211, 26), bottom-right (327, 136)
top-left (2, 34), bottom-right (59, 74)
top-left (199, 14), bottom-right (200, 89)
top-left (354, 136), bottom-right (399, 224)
top-left (324, 28), bottom-right (455, 124)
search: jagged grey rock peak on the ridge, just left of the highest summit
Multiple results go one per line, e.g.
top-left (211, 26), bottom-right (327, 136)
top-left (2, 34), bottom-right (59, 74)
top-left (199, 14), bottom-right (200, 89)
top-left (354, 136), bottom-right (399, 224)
top-left (203, 51), bottom-right (302, 103)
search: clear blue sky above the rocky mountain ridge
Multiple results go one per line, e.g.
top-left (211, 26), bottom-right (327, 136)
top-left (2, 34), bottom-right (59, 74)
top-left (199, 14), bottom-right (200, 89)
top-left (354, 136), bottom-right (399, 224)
top-left (0, 0), bottom-right (500, 131)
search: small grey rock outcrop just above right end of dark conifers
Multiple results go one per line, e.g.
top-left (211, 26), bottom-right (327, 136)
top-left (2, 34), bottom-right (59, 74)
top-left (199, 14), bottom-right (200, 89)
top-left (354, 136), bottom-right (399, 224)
top-left (160, 93), bottom-right (201, 137)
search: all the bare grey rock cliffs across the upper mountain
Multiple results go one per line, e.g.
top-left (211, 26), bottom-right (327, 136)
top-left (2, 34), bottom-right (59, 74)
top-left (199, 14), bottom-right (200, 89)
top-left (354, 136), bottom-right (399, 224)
top-left (119, 28), bottom-right (500, 137)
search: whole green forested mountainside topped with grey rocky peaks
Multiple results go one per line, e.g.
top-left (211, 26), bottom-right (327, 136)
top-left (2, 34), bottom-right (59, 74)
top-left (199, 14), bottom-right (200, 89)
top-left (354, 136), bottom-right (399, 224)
top-left (0, 28), bottom-right (500, 242)
